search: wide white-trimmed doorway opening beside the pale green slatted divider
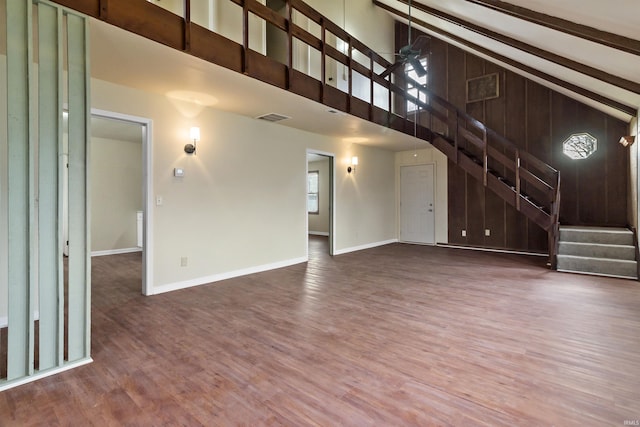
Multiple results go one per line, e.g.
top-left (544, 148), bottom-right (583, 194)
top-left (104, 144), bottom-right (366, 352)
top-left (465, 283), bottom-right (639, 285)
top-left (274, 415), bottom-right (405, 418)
top-left (91, 109), bottom-right (153, 295)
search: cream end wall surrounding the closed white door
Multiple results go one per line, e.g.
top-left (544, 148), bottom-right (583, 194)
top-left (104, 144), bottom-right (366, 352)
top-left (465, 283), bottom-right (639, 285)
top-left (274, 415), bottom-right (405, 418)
top-left (396, 146), bottom-right (449, 243)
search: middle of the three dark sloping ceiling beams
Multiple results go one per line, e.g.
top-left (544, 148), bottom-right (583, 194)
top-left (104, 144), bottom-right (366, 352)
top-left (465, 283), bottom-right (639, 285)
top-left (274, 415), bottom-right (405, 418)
top-left (392, 0), bottom-right (640, 94)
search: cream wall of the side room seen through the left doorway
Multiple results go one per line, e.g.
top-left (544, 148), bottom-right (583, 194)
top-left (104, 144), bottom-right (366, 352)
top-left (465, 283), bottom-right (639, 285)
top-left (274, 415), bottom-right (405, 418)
top-left (91, 136), bottom-right (142, 252)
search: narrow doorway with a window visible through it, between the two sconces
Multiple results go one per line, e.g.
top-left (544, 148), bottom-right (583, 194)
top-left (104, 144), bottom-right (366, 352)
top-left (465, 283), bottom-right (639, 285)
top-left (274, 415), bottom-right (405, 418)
top-left (307, 150), bottom-right (335, 258)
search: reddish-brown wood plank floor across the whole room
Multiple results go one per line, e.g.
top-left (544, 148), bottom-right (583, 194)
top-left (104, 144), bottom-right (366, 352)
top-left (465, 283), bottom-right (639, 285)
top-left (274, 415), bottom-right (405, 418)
top-left (0, 237), bottom-right (640, 426)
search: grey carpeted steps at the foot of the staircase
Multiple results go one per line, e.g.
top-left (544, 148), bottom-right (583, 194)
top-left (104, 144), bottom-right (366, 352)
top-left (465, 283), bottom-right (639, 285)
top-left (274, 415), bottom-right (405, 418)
top-left (558, 227), bottom-right (638, 279)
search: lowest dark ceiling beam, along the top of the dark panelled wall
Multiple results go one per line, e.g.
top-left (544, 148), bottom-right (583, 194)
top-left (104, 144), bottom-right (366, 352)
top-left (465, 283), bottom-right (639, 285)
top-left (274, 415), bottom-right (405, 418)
top-left (373, 0), bottom-right (637, 117)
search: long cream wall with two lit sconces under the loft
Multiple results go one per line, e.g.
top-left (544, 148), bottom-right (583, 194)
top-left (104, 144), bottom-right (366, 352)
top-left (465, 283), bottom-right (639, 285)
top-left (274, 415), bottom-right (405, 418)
top-left (92, 80), bottom-right (396, 293)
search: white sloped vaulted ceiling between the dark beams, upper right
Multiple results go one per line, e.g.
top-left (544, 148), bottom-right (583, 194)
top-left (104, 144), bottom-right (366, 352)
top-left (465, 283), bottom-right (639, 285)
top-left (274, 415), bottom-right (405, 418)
top-left (380, 0), bottom-right (640, 121)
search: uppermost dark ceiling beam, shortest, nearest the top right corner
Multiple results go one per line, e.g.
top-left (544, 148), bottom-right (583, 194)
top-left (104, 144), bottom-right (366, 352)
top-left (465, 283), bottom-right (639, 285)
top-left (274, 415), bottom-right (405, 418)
top-left (465, 0), bottom-right (640, 55)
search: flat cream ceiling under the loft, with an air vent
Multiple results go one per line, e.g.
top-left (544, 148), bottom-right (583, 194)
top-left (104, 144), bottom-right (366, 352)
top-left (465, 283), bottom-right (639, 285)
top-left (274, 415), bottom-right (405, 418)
top-left (90, 19), bottom-right (427, 151)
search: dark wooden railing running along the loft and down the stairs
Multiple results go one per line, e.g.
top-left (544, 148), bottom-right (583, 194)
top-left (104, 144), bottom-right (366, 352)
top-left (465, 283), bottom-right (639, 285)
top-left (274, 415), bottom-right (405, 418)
top-left (54, 0), bottom-right (560, 267)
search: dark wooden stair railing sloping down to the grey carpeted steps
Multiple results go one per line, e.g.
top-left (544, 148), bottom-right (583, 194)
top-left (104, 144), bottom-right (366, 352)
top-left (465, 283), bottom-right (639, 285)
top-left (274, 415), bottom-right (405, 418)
top-left (390, 76), bottom-right (560, 269)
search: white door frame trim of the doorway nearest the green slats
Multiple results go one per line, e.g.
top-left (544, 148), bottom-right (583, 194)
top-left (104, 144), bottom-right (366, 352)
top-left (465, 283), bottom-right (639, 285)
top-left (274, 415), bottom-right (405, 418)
top-left (91, 108), bottom-right (153, 296)
